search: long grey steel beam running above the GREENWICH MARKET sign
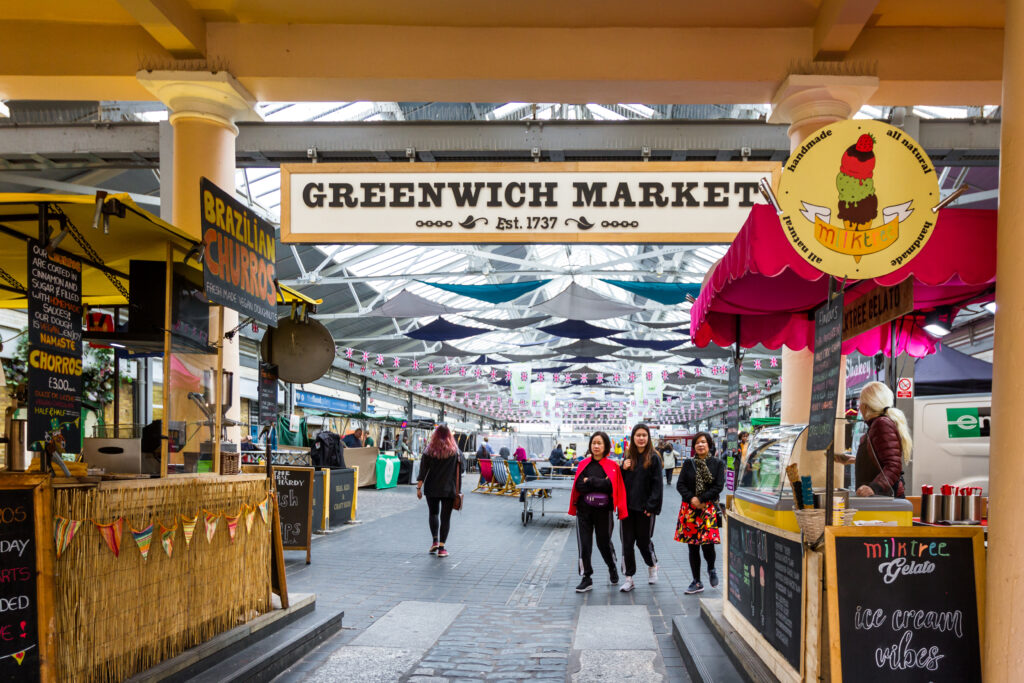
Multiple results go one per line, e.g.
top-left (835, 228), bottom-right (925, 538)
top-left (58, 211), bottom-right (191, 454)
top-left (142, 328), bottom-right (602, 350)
top-left (0, 119), bottom-right (1000, 170)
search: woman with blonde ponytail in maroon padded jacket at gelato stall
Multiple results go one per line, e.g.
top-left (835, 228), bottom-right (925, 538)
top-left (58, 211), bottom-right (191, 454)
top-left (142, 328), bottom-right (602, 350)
top-left (854, 382), bottom-right (913, 498)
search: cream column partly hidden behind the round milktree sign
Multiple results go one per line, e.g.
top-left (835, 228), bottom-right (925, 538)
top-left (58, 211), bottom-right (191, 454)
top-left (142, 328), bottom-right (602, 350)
top-left (768, 74), bottom-right (879, 432)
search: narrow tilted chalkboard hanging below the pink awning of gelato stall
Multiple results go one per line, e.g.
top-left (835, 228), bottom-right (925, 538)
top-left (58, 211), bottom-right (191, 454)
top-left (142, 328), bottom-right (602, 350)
top-left (807, 296), bottom-right (843, 451)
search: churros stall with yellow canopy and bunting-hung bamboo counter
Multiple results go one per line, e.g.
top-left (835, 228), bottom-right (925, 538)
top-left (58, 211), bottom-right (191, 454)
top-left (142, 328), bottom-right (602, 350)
top-left (0, 190), bottom-right (303, 681)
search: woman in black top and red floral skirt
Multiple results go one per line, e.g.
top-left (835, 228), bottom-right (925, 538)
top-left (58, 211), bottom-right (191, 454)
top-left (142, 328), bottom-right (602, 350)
top-left (676, 432), bottom-right (725, 595)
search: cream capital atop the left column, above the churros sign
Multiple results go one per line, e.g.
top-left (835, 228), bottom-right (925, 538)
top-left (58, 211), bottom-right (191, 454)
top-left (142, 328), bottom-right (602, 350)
top-left (135, 71), bottom-right (260, 134)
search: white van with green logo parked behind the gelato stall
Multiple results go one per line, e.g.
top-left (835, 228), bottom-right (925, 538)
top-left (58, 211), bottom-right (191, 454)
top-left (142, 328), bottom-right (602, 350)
top-left (905, 393), bottom-right (992, 496)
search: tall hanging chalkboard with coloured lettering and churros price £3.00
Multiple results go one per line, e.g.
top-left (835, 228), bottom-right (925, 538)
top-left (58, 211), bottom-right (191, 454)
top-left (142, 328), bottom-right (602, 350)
top-left (28, 242), bottom-right (82, 453)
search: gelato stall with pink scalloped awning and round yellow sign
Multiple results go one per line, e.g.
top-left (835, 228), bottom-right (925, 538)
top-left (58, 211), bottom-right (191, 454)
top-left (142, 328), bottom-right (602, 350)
top-left (690, 121), bottom-right (995, 681)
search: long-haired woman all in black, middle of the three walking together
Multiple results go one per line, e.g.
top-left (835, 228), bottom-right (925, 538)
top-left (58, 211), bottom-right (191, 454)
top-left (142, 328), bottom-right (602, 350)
top-left (618, 423), bottom-right (663, 593)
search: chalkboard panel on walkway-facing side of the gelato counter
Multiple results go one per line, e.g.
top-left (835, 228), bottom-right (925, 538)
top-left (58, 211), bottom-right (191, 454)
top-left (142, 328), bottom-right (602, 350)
top-left (727, 516), bottom-right (804, 671)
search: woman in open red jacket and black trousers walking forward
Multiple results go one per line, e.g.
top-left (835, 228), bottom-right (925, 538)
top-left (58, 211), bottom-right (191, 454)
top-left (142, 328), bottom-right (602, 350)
top-left (569, 432), bottom-right (629, 593)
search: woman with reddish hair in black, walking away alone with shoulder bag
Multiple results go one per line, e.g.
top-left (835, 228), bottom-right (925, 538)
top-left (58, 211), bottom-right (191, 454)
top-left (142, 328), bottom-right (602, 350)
top-left (416, 425), bottom-right (465, 557)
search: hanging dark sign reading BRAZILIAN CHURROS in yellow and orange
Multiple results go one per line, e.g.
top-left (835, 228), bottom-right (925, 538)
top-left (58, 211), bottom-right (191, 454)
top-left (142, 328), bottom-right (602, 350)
top-left (200, 178), bottom-right (278, 327)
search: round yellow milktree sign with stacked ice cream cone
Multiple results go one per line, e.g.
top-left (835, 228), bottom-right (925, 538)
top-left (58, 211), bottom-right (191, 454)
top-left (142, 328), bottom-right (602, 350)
top-left (778, 120), bottom-right (940, 280)
